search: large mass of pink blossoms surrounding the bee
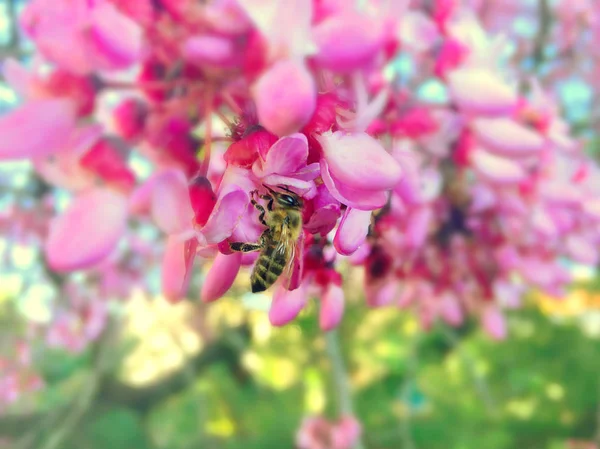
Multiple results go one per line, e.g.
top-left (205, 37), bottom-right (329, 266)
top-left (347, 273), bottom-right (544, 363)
top-left (0, 0), bottom-right (600, 350)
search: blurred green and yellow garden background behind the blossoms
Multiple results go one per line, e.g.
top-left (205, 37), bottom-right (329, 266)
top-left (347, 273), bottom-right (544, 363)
top-left (0, 0), bottom-right (600, 449)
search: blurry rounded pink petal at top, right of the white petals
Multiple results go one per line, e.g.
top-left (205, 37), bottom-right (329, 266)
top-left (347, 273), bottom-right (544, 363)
top-left (313, 10), bottom-right (383, 72)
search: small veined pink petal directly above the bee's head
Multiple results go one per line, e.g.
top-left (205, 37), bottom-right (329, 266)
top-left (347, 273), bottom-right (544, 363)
top-left (252, 133), bottom-right (308, 178)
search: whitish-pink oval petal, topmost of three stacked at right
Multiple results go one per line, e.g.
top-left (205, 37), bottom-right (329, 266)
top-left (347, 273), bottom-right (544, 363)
top-left (448, 68), bottom-right (518, 114)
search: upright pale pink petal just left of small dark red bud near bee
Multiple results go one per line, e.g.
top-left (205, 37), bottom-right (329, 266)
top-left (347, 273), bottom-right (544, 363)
top-left (151, 169), bottom-right (194, 234)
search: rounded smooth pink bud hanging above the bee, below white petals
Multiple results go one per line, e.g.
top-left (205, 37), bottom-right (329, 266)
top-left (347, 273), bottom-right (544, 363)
top-left (252, 60), bottom-right (317, 136)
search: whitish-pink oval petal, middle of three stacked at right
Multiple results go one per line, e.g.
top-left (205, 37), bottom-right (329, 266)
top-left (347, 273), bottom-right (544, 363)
top-left (471, 118), bottom-right (544, 157)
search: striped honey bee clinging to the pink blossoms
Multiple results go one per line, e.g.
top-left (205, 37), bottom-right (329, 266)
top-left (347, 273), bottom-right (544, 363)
top-left (229, 186), bottom-right (303, 293)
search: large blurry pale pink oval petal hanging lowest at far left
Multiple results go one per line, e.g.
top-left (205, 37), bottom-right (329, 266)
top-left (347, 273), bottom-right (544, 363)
top-left (45, 188), bottom-right (127, 271)
